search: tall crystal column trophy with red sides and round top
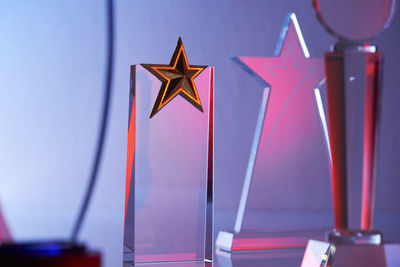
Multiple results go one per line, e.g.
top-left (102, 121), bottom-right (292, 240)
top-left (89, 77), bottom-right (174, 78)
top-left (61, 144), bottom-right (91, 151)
top-left (302, 0), bottom-right (400, 266)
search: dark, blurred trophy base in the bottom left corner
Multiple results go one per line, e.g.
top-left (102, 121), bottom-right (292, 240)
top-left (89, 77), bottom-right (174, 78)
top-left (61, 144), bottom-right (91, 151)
top-left (0, 241), bottom-right (101, 267)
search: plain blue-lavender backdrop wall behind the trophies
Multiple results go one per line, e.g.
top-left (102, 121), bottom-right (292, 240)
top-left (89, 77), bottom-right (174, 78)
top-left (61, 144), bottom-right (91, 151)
top-left (0, 0), bottom-right (400, 266)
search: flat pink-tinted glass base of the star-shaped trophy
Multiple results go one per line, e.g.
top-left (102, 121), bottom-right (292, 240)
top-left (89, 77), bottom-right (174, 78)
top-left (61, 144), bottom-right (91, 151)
top-left (215, 229), bottom-right (327, 252)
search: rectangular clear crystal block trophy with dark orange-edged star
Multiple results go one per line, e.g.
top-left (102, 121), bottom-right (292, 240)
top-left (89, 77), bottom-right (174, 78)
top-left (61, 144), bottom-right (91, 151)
top-left (123, 38), bottom-right (214, 265)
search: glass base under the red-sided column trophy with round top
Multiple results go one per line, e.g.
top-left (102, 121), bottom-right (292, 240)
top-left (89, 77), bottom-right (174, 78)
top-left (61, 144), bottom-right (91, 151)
top-left (301, 240), bottom-right (400, 267)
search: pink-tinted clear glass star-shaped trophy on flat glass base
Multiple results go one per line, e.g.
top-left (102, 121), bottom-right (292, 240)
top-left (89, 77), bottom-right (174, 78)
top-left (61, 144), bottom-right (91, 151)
top-left (216, 13), bottom-right (331, 252)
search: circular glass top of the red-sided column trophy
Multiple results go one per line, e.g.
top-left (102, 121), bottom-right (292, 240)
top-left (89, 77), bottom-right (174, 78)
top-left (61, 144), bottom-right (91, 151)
top-left (313, 0), bottom-right (396, 42)
